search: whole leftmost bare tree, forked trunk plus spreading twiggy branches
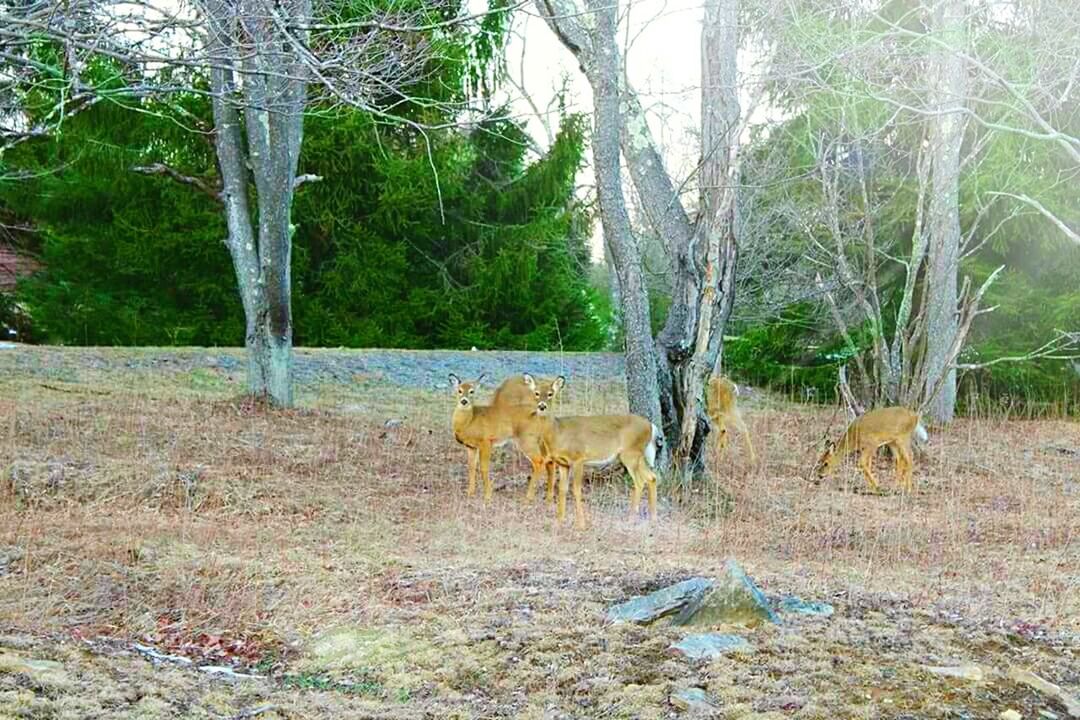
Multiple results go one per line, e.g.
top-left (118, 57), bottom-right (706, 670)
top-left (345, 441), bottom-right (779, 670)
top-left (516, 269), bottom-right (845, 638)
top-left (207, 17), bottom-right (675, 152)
top-left (0, 0), bottom-right (505, 406)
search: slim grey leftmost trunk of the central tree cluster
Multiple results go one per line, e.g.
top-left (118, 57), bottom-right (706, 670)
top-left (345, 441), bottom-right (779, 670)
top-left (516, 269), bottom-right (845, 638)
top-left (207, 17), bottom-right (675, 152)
top-left (589, 0), bottom-right (662, 426)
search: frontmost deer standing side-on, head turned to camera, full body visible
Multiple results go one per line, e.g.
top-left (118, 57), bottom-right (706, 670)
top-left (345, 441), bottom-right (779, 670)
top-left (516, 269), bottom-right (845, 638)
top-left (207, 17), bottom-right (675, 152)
top-left (517, 383), bottom-right (663, 529)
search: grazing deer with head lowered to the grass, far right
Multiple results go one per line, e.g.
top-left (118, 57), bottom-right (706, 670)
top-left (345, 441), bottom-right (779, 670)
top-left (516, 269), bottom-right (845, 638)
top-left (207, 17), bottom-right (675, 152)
top-left (814, 407), bottom-right (930, 492)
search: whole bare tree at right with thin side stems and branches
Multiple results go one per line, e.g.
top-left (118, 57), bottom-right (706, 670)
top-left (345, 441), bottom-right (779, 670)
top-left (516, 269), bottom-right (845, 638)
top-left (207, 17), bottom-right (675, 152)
top-left (773, 0), bottom-right (1080, 423)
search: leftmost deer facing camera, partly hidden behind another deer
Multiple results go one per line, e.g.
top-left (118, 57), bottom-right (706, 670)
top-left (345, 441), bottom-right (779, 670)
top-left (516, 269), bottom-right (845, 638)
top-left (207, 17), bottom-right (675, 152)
top-left (449, 372), bottom-right (566, 502)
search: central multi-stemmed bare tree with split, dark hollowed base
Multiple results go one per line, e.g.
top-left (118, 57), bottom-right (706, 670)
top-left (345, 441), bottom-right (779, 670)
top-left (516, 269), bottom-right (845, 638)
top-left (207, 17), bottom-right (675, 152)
top-left (536, 0), bottom-right (743, 476)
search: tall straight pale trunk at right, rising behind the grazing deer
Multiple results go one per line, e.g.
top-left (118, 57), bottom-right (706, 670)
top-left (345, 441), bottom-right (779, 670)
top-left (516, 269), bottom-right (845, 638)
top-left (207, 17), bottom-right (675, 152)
top-left (926, 0), bottom-right (967, 424)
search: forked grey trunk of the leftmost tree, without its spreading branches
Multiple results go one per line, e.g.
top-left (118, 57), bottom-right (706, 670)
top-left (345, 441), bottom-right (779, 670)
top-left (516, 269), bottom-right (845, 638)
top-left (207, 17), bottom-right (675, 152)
top-left (206, 0), bottom-right (311, 407)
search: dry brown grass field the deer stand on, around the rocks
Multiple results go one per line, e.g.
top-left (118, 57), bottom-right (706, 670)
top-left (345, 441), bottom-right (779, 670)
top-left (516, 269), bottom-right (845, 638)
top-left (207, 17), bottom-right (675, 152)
top-left (0, 348), bottom-right (1080, 720)
